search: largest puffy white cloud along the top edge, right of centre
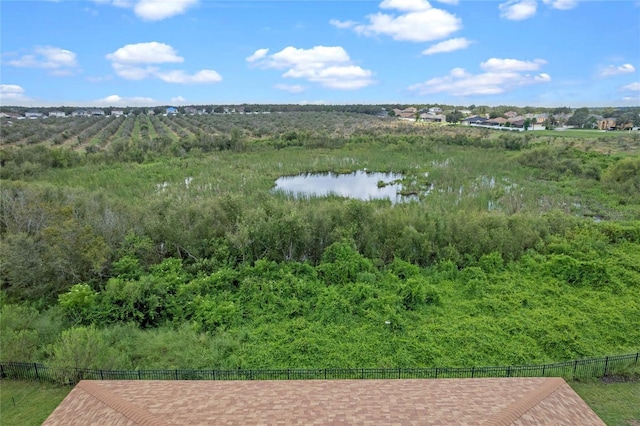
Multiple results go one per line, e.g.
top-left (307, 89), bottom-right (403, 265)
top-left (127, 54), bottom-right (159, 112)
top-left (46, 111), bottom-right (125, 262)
top-left (329, 0), bottom-right (462, 42)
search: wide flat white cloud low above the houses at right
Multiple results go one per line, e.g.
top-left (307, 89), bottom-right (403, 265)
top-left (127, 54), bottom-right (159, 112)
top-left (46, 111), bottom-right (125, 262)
top-left (409, 58), bottom-right (551, 96)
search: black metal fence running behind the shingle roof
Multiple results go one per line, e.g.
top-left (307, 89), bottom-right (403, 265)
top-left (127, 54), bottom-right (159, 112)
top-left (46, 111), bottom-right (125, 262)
top-left (0, 353), bottom-right (640, 385)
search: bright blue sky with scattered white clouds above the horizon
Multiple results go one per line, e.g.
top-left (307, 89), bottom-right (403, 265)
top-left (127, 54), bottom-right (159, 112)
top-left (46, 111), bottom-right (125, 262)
top-left (0, 0), bottom-right (640, 107)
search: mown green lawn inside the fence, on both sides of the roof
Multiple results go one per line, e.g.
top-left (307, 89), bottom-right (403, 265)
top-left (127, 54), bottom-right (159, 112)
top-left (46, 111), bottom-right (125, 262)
top-left (0, 380), bottom-right (640, 426)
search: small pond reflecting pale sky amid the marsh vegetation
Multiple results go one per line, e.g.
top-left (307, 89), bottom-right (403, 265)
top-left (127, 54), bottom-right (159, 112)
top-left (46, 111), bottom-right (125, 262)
top-left (274, 170), bottom-right (417, 204)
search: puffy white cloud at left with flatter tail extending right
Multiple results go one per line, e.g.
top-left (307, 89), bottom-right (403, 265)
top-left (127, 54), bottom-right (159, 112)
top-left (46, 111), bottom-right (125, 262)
top-left (106, 41), bottom-right (222, 84)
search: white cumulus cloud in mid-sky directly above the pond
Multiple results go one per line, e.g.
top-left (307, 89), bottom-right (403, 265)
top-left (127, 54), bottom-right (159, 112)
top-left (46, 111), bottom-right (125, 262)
top-left (247, 46), bottom-right (374, 90)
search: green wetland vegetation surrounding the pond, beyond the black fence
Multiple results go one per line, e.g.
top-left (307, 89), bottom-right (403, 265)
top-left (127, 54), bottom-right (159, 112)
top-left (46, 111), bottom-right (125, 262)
top-left (0, 112), bottom-right (640, 369)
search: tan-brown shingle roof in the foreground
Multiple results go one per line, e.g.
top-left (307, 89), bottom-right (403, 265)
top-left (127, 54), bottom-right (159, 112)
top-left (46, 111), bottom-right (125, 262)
top-left (44, 378), bottom-right (604, 426)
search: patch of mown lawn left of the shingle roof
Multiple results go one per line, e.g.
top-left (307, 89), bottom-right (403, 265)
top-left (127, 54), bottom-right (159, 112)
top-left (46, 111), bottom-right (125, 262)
top-left (0, 380), bottom-right (72, 426)
